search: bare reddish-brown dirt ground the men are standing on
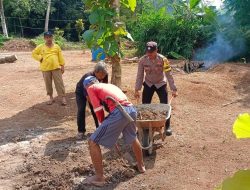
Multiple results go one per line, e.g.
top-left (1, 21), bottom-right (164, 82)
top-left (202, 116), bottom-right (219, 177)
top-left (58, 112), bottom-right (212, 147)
top-left (0, 51), bottom-right (250, 190)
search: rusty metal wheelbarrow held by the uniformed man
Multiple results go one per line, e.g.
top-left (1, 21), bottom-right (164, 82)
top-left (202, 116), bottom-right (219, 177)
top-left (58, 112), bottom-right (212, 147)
top-left (136, 104), bottom-right (171, 155)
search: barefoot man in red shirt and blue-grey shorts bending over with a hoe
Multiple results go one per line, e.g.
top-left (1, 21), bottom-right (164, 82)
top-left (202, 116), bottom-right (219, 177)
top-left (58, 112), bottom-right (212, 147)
top-left (83, 76), bottom-right (146, 186)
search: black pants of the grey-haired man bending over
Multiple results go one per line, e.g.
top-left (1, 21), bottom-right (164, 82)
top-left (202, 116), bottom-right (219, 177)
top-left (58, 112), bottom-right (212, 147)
top-left (76, 94), bottom-right (99, 133)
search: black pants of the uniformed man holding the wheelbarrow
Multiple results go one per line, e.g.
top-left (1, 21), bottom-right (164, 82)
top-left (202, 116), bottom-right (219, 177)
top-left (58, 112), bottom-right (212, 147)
top-left (142, 82), bottom-right (170, 129)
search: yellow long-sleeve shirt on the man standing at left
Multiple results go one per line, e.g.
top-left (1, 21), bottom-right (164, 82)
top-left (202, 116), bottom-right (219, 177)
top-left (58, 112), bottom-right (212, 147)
top-left (32, 44), bottom-right (65, 71)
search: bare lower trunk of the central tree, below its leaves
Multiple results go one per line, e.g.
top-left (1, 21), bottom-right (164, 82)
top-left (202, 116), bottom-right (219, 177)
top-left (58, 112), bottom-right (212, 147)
top-left (111, 55), bottom-right (122, 87)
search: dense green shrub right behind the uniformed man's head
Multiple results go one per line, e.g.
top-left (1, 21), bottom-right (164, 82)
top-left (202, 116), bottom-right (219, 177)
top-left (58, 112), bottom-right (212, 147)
top-left (127, 11), bottom-right (215, 58)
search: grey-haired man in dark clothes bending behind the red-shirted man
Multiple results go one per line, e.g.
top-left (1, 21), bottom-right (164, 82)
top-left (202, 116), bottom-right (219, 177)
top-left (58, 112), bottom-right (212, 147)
top-left (75, 61), bottom-right (108, 140)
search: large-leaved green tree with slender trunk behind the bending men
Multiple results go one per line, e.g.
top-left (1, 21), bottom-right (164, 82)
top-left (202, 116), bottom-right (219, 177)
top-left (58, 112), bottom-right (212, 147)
top-left (83, 0), bottom-right (136, 86)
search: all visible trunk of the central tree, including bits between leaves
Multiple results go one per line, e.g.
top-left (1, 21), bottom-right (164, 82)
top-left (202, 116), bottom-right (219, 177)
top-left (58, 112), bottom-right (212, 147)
top-left (111, 0), bottom-right (122, 87)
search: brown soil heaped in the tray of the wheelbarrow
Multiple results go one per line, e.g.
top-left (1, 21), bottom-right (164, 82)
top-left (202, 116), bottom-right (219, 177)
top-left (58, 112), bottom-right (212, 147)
top-left (136, 104), bottom-right (169, 120)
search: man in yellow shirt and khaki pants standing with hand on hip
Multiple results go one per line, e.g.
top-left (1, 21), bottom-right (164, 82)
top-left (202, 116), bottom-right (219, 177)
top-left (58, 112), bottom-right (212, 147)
top-left (32, 31), bottom-right (67, 106)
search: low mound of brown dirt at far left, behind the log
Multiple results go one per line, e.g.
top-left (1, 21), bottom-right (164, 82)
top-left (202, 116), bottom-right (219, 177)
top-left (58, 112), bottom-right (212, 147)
top-left (2, 38), bottom-right (35, 51)
